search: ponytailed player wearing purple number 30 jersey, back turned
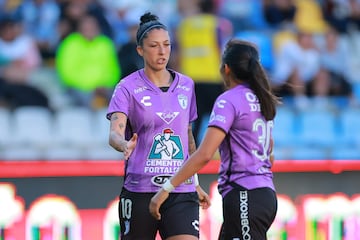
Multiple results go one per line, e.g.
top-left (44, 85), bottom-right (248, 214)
top-left (149, 40), bottom-right (278, 240)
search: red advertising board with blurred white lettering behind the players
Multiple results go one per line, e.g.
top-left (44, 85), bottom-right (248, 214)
top-left (0, 160), bottom-right (360, 240)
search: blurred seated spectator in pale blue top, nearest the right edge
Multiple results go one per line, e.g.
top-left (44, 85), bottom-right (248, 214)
top-left (318, 27), bottom-right (352, 96)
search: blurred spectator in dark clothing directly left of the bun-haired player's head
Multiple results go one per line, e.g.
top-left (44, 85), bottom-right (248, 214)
top-left (118, 9), bottom-right (144, 78)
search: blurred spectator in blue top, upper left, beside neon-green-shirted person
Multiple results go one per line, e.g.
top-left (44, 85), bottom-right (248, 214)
top-left (13, 0), bottom-right (60, 59)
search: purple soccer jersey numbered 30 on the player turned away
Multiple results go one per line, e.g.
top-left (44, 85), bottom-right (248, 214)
top-left (208, 85), bottom-right (275, 196)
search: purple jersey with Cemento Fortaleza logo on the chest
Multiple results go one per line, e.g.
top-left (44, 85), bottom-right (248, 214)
top-left (107, 69), bottom-right (197, 192)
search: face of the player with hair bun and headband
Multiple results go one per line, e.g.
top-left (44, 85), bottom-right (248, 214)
top-left (137, 29), bottom-right (171, 71)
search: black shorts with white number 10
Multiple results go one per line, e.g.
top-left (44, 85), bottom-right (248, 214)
top-left (119, 189), bottom-right (199, 240)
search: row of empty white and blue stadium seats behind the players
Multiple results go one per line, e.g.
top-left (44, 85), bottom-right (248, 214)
top-left (0, 97), bottom-right (360, 161)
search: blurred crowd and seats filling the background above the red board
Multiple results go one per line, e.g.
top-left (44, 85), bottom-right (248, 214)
top-left (0, 0), bottom-right (360, 160)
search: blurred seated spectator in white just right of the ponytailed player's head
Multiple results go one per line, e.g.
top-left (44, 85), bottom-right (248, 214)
top-left (272, 31), bottom-right (330, 108)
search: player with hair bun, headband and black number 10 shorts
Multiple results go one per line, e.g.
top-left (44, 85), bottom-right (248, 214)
top-left (107, 13), bottom-right (210, 240)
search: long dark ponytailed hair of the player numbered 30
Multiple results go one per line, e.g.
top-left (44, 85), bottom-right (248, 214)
top-left (222, 39), bottom-right (280, 120)
